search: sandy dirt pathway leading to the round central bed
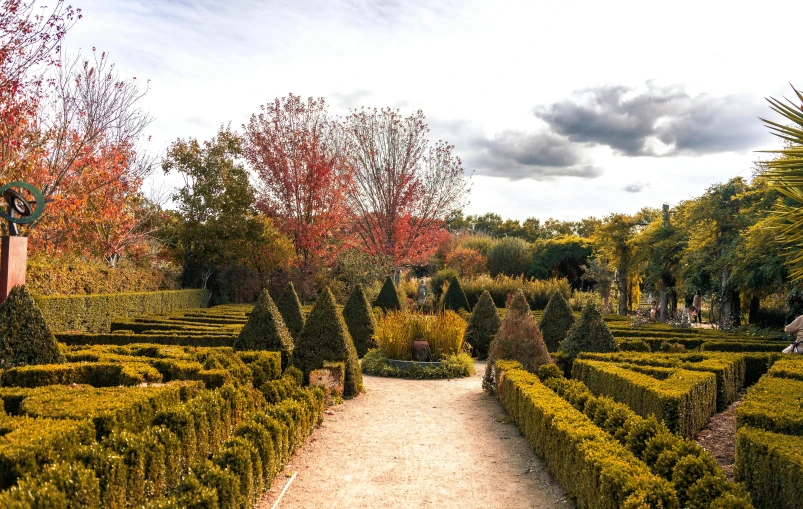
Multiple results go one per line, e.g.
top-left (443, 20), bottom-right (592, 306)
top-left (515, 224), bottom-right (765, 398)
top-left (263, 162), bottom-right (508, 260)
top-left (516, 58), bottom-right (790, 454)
top-left (258, 363), bottom-right (572, 509)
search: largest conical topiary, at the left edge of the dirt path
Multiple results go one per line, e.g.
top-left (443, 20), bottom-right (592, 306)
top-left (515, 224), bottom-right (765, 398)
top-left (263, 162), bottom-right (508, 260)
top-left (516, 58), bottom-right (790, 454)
top-left (293, 288), bottom-right (363, 397)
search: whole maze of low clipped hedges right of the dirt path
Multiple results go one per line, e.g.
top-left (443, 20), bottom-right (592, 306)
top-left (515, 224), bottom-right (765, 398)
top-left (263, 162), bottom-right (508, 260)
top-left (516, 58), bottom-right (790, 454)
top-left (490, 313), bottom-right (803, 509)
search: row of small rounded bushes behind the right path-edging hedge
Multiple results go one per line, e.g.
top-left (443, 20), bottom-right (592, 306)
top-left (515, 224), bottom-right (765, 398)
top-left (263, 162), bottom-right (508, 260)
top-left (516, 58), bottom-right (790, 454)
top-left (538, 368), bottom-right (751, 508)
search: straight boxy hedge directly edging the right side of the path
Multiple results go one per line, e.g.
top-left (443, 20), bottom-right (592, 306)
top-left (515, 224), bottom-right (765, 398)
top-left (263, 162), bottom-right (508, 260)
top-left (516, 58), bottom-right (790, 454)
top-left (495, 361), bottom-right (679, 509)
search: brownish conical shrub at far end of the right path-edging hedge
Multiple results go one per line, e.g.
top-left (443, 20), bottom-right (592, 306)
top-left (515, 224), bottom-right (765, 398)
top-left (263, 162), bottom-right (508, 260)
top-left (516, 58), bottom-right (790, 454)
top-left (488, 290), bottom-right (552, 373)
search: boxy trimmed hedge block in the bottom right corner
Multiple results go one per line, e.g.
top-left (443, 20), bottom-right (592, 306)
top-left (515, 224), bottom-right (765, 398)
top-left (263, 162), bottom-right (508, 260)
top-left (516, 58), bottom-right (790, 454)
top-left (733, 426), bottom-right (803, 509)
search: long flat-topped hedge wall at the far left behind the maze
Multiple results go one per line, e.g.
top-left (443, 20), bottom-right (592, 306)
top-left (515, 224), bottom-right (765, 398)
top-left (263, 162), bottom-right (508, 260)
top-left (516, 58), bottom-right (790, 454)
top-left (36, 290), bottom-right (208, 332)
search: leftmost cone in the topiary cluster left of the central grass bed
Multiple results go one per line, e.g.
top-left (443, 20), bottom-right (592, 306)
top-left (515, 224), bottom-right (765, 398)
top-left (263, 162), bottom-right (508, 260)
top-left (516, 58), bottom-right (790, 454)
top-left (234, 290), bottom-right (293, 368)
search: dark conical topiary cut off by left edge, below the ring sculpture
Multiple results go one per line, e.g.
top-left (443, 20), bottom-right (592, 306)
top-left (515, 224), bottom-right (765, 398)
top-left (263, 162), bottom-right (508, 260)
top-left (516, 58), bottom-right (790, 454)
top-left (0, 286), bottom-right (64, 368)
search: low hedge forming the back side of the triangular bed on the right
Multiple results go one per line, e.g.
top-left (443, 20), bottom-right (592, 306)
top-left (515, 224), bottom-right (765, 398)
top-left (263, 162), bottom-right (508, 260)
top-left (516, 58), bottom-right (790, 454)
top-left (580, 352), bottom-right (747, 412)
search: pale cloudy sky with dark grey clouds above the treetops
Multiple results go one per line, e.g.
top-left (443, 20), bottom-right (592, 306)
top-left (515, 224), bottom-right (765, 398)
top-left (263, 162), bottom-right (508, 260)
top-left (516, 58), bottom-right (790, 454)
top-left (65, 0), bottom-right (803, 219)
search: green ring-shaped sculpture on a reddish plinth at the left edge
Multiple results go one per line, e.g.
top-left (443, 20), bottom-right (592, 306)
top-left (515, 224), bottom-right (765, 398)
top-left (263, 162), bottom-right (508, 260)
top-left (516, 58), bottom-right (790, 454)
top-left (0, 182), bottom-right (45, 303)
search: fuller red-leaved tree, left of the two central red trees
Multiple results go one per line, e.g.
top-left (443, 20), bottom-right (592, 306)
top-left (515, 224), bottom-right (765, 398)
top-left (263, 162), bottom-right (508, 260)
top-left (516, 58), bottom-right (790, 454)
top-left (243, 94), bottom-right (350, 263)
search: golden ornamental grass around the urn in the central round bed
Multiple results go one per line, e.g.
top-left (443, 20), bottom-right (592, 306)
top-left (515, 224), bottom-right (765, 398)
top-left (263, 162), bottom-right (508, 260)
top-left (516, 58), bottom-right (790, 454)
top-left (374, 311), bottom-right (467, 361)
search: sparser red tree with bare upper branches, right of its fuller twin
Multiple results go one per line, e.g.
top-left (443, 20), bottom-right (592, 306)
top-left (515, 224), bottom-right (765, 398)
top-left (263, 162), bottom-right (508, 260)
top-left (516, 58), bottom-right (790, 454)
top-left (344, 108), bottom-right (469, 264)
